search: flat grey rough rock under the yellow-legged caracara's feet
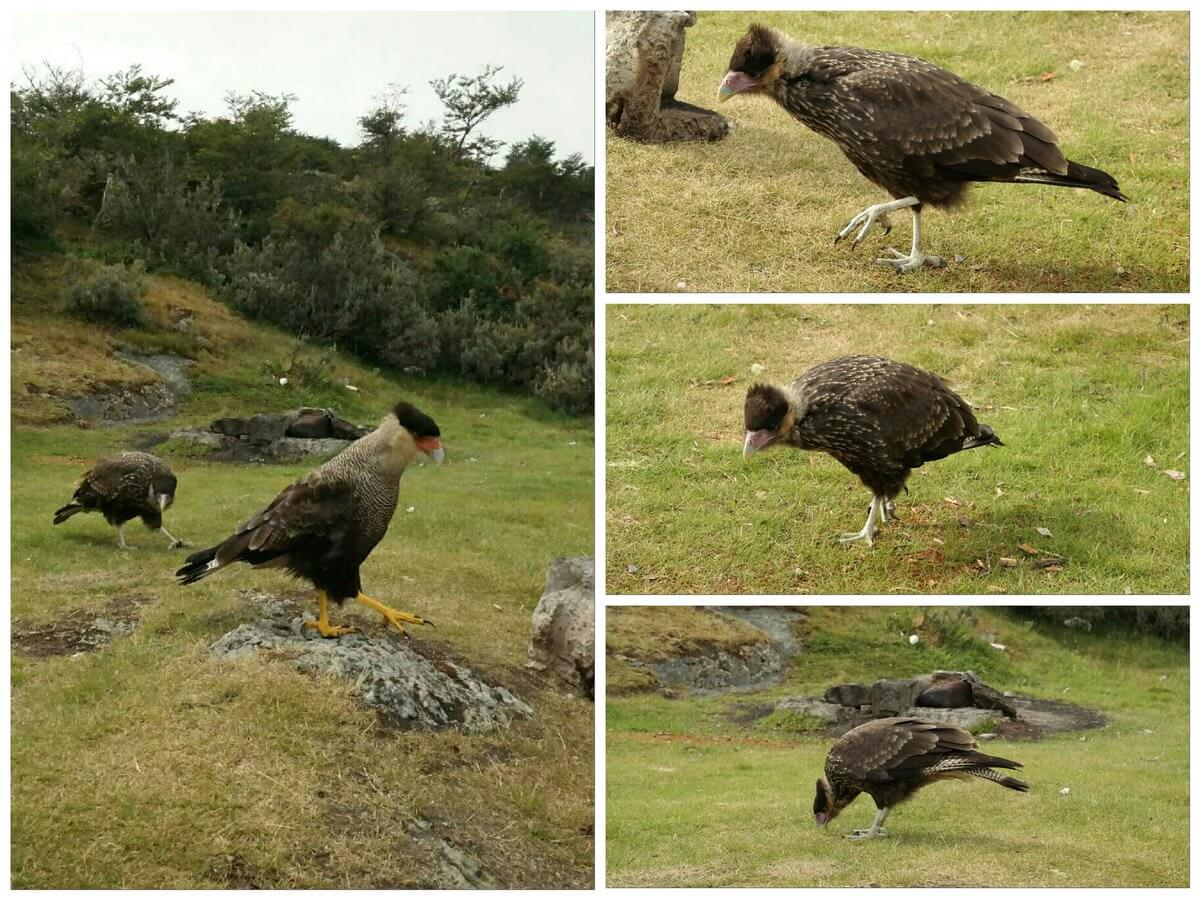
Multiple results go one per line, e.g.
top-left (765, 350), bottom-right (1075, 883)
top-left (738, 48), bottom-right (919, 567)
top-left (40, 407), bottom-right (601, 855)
top-left (210, 618), bottom-right (533, 734)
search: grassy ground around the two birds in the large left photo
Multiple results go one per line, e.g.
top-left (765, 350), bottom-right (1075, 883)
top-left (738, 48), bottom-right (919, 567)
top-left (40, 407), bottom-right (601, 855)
top-left (12, 252), bottom-right (593, 888)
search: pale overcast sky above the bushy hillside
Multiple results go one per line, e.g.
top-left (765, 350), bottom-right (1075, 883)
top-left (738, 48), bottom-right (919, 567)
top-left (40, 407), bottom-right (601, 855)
top-left (10, 12), bottom-right (595, 162)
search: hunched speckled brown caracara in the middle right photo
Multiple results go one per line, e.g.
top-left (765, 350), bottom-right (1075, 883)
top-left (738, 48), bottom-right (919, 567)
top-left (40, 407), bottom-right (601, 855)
top-left (743, 356), bottom-right (1003, 546)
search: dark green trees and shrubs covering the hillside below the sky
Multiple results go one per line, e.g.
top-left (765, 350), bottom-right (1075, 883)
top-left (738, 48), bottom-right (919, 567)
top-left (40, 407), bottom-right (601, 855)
top-left (11, 65), bottom-right (594, 415)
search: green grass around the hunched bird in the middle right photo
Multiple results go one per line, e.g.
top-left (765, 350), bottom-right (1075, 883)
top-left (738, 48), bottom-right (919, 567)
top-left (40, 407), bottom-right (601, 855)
top-left (606, 304), bottom-right (1188, 594)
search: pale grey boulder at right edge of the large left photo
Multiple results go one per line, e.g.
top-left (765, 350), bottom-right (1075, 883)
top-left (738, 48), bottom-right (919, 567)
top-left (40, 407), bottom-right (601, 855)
top-left (526, 557), bottom-right (596, 698)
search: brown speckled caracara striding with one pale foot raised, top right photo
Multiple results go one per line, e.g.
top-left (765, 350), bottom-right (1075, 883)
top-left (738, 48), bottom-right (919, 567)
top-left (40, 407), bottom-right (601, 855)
top-left (719, 25), bottom-right (1126, 272)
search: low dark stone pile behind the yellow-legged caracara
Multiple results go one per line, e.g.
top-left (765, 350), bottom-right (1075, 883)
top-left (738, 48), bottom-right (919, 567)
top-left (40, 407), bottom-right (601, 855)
top-left (160, 407), bottom-right (370, 462)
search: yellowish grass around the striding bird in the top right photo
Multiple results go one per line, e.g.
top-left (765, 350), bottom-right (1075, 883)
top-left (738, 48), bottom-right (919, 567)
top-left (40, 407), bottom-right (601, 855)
top-left (606, 11), bottom-right (1189, 292)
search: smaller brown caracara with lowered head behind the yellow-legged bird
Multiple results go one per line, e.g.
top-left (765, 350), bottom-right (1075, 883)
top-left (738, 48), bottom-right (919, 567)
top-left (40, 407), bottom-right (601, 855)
top-left (54, 450), bottom-right (187, 550)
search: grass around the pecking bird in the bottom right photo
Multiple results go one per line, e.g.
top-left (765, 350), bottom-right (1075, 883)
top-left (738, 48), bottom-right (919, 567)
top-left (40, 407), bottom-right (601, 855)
top-left (607, 606), bottom-right (1188, 887)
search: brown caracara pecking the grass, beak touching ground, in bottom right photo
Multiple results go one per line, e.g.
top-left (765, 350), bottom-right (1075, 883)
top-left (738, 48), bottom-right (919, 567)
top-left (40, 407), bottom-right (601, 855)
top-left (812, 718), bottom-right (1030, 838)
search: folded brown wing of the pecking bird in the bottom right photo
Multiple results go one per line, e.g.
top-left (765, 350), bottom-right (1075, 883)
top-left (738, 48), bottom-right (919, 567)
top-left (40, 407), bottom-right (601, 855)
top-left (827, 716), bottom-right (976, 781)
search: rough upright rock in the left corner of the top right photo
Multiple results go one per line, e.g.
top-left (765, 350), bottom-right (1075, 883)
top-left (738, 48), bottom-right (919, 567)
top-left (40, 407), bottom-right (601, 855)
top-left (605, 11), bottom-right (730, 143)
